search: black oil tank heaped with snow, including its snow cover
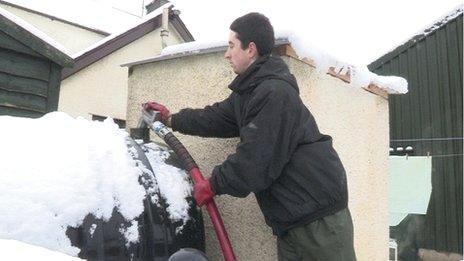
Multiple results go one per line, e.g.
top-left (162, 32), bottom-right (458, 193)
top-left (0, 112), bottom-right (205, 261)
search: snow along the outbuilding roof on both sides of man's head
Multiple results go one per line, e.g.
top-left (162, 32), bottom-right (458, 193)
top-left (122, 31), bottom-right (408, 94)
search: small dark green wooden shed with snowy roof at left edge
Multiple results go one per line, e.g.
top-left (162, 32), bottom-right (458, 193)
top-left (0, 8), bottom-right (74, 118)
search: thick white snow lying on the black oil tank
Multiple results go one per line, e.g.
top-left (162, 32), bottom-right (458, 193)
top-left (0, 112), bottom-right (190, 256)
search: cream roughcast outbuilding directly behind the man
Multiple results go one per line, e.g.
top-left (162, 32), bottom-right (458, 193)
top-left (123, 37), bottom-right (407, 260)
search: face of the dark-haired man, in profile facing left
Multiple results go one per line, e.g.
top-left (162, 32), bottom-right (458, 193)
top-left (224, 31), bottom-right (257, 74)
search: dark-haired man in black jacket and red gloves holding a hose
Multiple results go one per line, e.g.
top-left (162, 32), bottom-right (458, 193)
top-left (145, 13), bottom-right (356, 261)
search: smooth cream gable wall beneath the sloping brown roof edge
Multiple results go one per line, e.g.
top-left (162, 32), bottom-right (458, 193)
top-left (58, 23), bottom-right (183, 120)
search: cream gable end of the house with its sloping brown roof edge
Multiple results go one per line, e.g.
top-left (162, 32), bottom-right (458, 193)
top-left (58, 4), bottom-right (193, 127)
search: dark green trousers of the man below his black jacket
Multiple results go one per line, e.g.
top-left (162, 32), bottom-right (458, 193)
top-left (277, 208), bottom-right (356, 261)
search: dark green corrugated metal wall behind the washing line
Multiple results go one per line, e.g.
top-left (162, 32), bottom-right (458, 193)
top-left (369, 12), bottom-right (463, 254)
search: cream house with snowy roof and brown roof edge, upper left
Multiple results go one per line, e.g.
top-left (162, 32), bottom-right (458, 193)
top-left (0, 0), bottom-right (193, 127)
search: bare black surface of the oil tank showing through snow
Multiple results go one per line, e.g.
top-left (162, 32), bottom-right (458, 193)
top-left (66, 138), bottom-right (205, 261)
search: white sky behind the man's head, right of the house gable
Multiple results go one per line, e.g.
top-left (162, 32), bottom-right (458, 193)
top-left (165, 0), bottom-right (463, 65)
